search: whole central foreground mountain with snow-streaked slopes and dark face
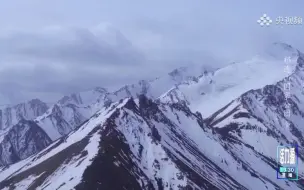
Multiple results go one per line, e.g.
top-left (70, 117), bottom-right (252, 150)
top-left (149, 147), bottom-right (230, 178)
top-left (0, 96), bottom-right (303, 190)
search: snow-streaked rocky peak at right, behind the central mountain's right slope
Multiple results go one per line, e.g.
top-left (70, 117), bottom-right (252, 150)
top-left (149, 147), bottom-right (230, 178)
top-left (207, 65), bottom-right (304, 153)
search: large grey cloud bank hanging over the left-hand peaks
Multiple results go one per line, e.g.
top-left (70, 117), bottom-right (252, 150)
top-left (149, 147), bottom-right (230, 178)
top-left (0, 27), bottom-right (151, 102)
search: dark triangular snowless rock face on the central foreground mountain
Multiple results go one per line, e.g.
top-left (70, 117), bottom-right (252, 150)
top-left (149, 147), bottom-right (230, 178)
top-left (75, 122), bottom-right (154, 190)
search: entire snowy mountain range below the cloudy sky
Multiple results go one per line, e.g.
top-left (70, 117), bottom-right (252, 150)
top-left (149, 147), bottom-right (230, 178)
top-left (0, 43), bottom-right (304, 190)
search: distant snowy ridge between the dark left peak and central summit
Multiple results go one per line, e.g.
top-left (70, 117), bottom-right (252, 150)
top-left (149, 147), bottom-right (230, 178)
top-left (35, 87), bottom-right (109, 140)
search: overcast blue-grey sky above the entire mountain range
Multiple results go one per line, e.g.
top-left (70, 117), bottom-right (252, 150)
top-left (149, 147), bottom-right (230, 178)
top-left (0, 0), bottom-right (304, 104)
